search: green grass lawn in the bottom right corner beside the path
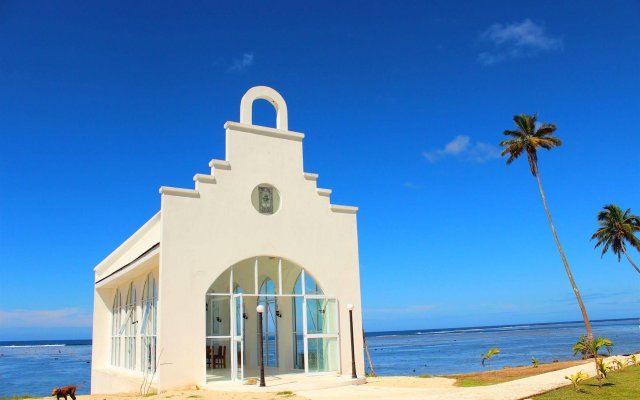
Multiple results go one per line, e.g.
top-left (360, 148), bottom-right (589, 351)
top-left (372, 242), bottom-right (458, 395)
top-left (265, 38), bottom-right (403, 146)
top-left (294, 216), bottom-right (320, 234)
top-left (535, 366), bottom-right (640, 400)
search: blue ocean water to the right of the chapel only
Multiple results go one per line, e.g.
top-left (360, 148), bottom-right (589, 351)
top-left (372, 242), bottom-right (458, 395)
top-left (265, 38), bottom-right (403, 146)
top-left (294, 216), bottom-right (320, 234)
top-left (365, 318), bottom-right (640, 375)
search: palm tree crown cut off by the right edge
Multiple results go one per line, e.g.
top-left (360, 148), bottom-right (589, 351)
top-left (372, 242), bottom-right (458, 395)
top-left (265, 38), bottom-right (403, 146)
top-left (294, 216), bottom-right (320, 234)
top-left (591, 204), bottom-right (640, 273)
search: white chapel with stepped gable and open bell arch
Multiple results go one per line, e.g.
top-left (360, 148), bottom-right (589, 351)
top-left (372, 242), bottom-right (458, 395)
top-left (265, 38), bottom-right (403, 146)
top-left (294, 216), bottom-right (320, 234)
top-left (91, 86), bottom-right (364, 393)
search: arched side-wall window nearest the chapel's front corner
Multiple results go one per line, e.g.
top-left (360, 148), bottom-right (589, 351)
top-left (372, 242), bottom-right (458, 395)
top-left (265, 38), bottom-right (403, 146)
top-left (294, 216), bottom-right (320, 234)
top-left (140, 274), bottom-right (158, 372)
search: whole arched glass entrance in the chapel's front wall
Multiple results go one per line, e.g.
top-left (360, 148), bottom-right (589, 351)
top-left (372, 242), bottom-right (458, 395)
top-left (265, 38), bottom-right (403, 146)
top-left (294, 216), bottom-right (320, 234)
top-left (205, 256), bottom-right (340, 382)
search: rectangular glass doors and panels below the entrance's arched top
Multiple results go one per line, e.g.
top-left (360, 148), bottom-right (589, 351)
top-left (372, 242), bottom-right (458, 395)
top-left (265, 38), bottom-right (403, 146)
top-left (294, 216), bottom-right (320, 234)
top-left (207, 293), bottom-right (339, 381)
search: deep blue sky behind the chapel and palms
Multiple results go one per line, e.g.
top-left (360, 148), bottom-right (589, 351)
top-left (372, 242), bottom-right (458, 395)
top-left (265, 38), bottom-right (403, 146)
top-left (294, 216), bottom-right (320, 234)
top-left (0, 1), bottom-right (640, 340)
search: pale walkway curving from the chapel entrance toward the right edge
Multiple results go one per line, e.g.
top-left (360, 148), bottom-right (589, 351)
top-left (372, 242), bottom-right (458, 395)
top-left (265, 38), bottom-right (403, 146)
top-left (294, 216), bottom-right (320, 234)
top-left (295, 356), bottom-right (628, 400)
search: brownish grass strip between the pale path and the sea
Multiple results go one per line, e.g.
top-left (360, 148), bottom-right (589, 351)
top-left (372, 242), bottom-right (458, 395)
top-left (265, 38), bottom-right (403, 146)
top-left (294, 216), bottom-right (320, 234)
top-left (446, 360), bottom-right (590, 387)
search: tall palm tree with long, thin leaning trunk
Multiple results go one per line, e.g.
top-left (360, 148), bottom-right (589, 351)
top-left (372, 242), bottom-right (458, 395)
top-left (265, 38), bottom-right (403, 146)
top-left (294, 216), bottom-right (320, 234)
top-left (500, 114), bottom-right (593, 340)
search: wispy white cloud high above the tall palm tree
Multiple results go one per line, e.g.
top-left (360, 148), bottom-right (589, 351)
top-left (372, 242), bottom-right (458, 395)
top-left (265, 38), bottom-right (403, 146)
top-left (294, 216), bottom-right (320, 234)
top-left (478, 18), bottom-right (562, 65)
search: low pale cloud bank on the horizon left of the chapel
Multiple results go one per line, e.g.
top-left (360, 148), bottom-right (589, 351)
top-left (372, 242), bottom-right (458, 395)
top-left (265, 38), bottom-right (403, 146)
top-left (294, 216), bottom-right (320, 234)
top-left (0, 308), bottom-right (92, 329)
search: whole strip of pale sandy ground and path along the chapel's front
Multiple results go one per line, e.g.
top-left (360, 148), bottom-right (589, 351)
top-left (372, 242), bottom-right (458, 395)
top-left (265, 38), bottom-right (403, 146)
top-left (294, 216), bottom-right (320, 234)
top-left (30, 354), bottom-right (640, 400)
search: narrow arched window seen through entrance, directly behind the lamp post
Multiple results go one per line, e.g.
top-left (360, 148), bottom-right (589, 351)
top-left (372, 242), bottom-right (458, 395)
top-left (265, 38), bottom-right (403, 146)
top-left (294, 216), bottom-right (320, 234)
top-left (258, 278), bottom-right (279, 367)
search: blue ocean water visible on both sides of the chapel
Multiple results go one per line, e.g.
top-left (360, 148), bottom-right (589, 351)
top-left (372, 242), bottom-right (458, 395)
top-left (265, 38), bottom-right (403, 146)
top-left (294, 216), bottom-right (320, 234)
top-left (0, 319), bottom-right (640, 397)
